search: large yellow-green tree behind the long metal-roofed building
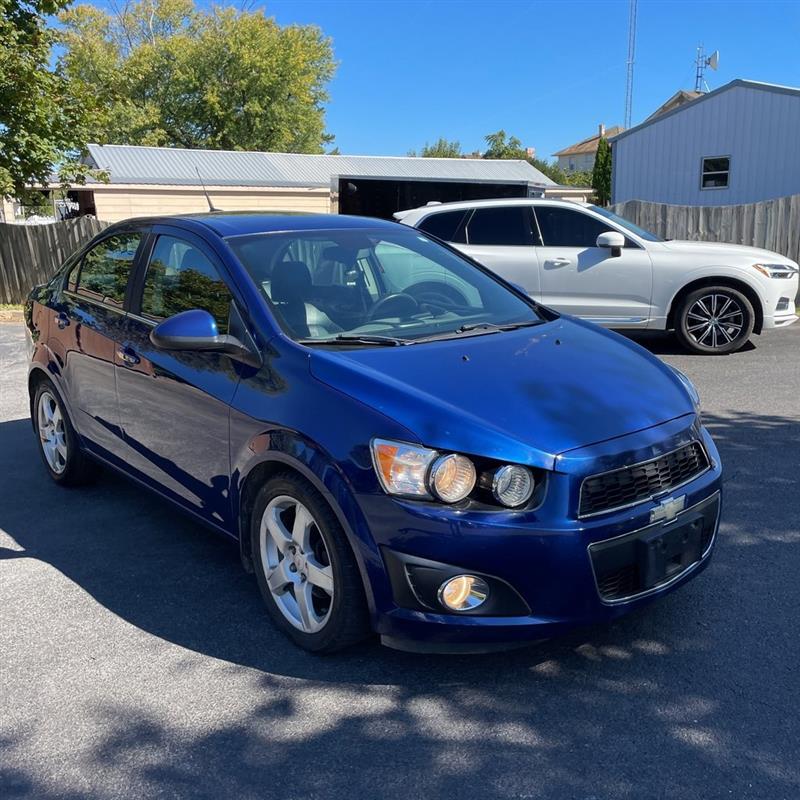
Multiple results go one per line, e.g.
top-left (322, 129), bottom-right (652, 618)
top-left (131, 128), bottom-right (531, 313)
top-left (60, 0), bottom-right (335, 153)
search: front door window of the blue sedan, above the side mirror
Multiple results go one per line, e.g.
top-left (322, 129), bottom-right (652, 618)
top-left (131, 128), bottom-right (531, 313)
top-left (141, 236), bottom-right (232, 333)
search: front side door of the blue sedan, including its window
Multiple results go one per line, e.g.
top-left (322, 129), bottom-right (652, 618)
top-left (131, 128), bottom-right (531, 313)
top-left (116, 226), bottom-right (240, 528)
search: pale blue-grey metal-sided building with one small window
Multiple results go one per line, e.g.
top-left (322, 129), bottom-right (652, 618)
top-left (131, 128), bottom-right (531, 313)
top-left (610, 80), bottom-right (800, 206)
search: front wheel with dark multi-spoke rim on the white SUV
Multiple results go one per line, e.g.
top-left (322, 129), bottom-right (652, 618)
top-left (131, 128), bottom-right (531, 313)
top-left (675, 286), bottom-right (755, 355)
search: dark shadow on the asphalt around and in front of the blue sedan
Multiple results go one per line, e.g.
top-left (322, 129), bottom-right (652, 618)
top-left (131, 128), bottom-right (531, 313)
top-left (0, 415), bottom-right (800, 800)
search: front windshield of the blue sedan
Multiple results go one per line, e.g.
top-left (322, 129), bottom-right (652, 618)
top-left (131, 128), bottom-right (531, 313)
top-left (227, 229), bottom-right (544, 345)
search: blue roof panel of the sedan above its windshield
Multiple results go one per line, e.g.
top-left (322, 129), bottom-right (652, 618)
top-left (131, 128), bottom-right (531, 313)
top-left (108, 211), bottom-right (397, 238)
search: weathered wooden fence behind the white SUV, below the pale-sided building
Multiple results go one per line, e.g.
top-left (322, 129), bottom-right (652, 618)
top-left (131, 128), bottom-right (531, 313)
top-left (611, 194), bottom-right (800, 268)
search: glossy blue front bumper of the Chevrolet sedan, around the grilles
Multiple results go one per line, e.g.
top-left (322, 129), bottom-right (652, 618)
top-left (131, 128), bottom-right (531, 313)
top-left (361, 420), bottom-right (721, 651)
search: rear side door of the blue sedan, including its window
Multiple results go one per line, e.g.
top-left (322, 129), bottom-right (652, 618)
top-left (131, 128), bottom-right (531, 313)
top-left (54, 228), bottom-right (145, 458)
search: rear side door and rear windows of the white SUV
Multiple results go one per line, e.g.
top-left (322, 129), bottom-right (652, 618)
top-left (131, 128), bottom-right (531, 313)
top-left (419, 204), bottom-right (540, 300)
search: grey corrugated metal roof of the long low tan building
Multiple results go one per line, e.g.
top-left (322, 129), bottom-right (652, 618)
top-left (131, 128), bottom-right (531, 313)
top-left (88, 144), bottom-right (556, 188)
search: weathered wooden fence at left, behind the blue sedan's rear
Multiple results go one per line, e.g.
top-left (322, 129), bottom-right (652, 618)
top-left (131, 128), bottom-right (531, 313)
top-left (0, 217), bottom-right (108, 303)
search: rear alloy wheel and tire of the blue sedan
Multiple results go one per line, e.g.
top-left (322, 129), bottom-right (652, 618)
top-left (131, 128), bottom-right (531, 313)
top-left (33, 379), bottom-right (97, 486)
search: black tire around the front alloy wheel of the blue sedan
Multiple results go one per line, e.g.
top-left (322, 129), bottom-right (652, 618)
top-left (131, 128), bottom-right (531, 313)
top-left (250, 472), bottom-right (370, 653)
